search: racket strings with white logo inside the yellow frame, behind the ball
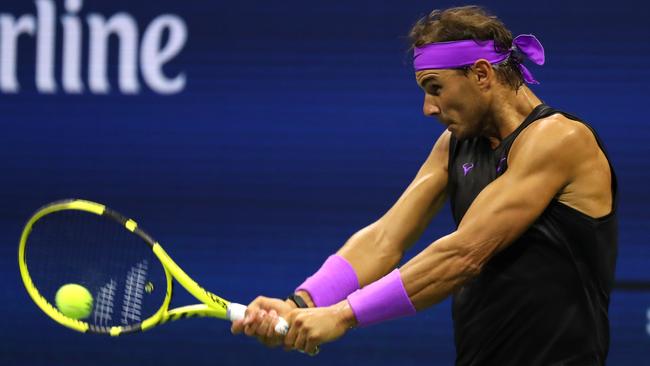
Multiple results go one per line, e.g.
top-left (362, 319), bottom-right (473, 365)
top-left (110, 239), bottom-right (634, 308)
top-left (25, 210), bottom-right (166, 327)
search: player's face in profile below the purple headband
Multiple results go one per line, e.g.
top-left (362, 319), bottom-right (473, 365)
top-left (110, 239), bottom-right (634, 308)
top-left (415, 70), bottom-right (487, 140)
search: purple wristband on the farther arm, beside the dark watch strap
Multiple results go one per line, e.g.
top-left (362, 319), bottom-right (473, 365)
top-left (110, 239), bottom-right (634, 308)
top-left (296, 254), bottom-right (359, 306)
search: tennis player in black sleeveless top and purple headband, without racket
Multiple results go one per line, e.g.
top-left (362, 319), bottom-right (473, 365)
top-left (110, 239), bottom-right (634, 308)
top-left (232, 6), bottom-right (617, 366)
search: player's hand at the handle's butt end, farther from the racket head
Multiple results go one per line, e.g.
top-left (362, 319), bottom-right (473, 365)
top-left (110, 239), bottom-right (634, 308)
top-left (284, 300), bottom-right (356, 355)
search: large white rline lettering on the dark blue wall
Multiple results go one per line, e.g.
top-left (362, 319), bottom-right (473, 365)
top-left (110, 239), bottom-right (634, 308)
top-left (0, 0), bottom-right (187, 94)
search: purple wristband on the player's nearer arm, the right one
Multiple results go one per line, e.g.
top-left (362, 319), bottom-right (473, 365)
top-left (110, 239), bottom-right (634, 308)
top-left (348, 269), bottom-right (416, 327)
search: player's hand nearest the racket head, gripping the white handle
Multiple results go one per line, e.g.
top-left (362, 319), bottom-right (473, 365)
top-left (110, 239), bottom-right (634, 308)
top-left (230, 296), bottom-right (296, 347)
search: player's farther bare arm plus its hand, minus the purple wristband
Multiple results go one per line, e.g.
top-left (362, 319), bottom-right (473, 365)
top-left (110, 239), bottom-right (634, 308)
top-left (232, 131), bottom-right (451, 338)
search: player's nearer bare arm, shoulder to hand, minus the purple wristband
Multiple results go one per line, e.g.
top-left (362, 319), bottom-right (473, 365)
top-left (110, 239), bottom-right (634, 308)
top-left (274, 119), bottom-right (611, 351)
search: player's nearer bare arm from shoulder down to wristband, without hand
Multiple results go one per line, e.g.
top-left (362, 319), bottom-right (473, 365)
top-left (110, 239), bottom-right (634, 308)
top-left (401, 117), bottom-right (609, 309)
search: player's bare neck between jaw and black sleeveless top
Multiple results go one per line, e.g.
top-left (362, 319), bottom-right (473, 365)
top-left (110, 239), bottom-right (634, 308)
top-left (482, 85), bottom-right (542, 147)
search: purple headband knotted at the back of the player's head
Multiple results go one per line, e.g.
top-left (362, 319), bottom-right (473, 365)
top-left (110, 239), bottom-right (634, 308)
top-left (413, 34), bottom-right (544, 84)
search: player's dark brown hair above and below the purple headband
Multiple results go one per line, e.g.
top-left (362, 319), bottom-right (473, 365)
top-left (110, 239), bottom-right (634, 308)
top-left (409, 5), bottom-right (524, 90)
